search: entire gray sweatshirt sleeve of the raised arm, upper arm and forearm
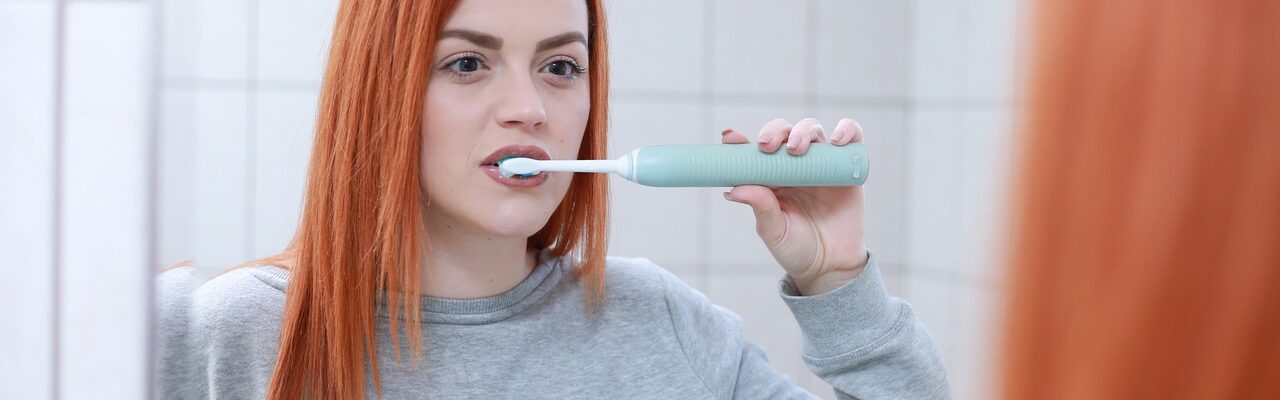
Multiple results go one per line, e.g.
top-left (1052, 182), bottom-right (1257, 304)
top-left (663, 252), bottom-right (950, 399)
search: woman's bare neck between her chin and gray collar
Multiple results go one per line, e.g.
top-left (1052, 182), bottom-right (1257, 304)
top-left (419, 218), bottom-right (538, 299)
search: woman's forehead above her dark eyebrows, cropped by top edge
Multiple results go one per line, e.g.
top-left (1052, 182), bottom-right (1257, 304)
top-left (444, 0), bottom-right (588, 46)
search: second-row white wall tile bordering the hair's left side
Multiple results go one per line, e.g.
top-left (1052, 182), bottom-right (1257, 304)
top-left (250, 90), bottom-right (317, 258)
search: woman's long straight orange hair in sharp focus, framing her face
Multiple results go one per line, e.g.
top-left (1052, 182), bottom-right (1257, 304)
top-left (249, 0), bottom-right (608, 399)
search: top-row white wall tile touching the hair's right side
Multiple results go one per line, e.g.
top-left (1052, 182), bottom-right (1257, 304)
top-left (605, 0), bottom-right (709, 94)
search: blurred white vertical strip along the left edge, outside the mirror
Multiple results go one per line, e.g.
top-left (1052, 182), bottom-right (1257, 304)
top-left (0, 0), bottom-right (159, 399)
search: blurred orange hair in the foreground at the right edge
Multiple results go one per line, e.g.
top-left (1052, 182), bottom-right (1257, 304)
top-left (1002, 0), bottom-right (1280, 399)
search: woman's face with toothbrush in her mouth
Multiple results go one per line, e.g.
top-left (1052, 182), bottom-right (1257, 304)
top-left (421, 0), bottom-right (590, 237)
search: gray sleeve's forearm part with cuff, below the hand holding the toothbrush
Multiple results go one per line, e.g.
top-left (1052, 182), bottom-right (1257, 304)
top-left (778, 255), bottom-right (950, 399)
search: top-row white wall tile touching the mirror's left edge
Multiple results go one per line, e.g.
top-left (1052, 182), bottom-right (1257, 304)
top-left (161, 0), bottom-right (251, 81)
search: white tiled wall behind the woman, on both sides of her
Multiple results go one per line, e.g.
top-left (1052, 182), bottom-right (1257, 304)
top-left (152, 0), bottom-right (1018, 399)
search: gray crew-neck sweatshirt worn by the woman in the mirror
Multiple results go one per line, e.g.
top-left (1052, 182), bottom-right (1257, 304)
top-left (155, 250), bottom-right (950, 399)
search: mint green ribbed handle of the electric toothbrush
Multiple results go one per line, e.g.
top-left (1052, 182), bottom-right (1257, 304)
top-left (627, 142), bottom-right (870, 187)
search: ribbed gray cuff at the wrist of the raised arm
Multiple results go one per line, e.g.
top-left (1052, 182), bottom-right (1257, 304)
top-left (778, 255), bottom-right (900, 358)
